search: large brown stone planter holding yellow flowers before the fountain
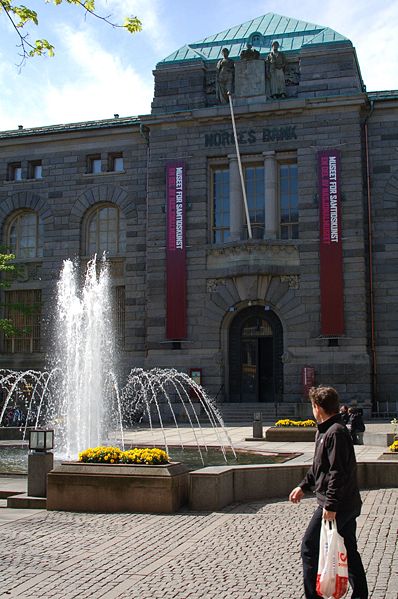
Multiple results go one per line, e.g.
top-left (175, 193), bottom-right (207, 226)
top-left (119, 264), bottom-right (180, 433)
top-left (47, 462), bottom-right (188, 514)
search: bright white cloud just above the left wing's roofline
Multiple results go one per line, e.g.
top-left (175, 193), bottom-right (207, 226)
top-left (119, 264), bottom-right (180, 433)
top-left (0, 27), bottom-right (153, 129)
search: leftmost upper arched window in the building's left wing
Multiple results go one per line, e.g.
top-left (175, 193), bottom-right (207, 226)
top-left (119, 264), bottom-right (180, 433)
top-left (6, 210), bottom-right (43, 259)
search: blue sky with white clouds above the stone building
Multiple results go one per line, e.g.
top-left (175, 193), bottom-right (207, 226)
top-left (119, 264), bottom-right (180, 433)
top-left (0, 0), bottom-right (398, 130)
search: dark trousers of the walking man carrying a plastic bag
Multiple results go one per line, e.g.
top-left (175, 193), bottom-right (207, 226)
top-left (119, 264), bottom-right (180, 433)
top-left (301, 507), bottom-right (368, 599)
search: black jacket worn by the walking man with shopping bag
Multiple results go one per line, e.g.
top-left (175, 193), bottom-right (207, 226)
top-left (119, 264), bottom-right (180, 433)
top-left (299, 414), bottom-right (362, 512)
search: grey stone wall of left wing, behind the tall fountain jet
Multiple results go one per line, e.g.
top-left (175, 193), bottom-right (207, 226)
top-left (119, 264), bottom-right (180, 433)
top-left (0, 125), bottom-right (147, 376)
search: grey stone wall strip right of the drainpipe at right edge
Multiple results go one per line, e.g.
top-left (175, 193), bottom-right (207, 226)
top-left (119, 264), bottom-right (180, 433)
top-left (367, 99), bottom-right (398, 414)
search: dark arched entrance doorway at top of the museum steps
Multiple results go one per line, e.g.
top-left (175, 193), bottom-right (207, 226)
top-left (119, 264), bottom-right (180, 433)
top-left (229, 306), bottom-right (283, 403)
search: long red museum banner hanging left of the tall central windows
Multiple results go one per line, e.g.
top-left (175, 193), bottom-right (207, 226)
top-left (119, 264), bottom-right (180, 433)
top-left (166, 162), bottom-right (187, 340)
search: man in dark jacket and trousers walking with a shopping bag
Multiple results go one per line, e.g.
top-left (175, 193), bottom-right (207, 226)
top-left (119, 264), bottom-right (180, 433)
top-left (289, 387), bottom-right (368, 599)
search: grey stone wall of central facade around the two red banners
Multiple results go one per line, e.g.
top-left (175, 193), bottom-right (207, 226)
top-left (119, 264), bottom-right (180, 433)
top-left (146, 96), bottom-right (371, 409)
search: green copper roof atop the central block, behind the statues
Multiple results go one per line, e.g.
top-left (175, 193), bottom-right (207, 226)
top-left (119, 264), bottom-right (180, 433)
top-left (159, 12), bottom-right (348, 64)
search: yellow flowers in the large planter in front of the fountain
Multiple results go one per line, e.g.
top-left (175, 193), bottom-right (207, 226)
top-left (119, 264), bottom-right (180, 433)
top-left (79, 447), bottom-right (170, 465)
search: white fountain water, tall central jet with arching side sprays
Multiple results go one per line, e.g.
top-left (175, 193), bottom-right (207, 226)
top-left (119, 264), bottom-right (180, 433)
top-left (0, 257), bottom-right (233, 462)
